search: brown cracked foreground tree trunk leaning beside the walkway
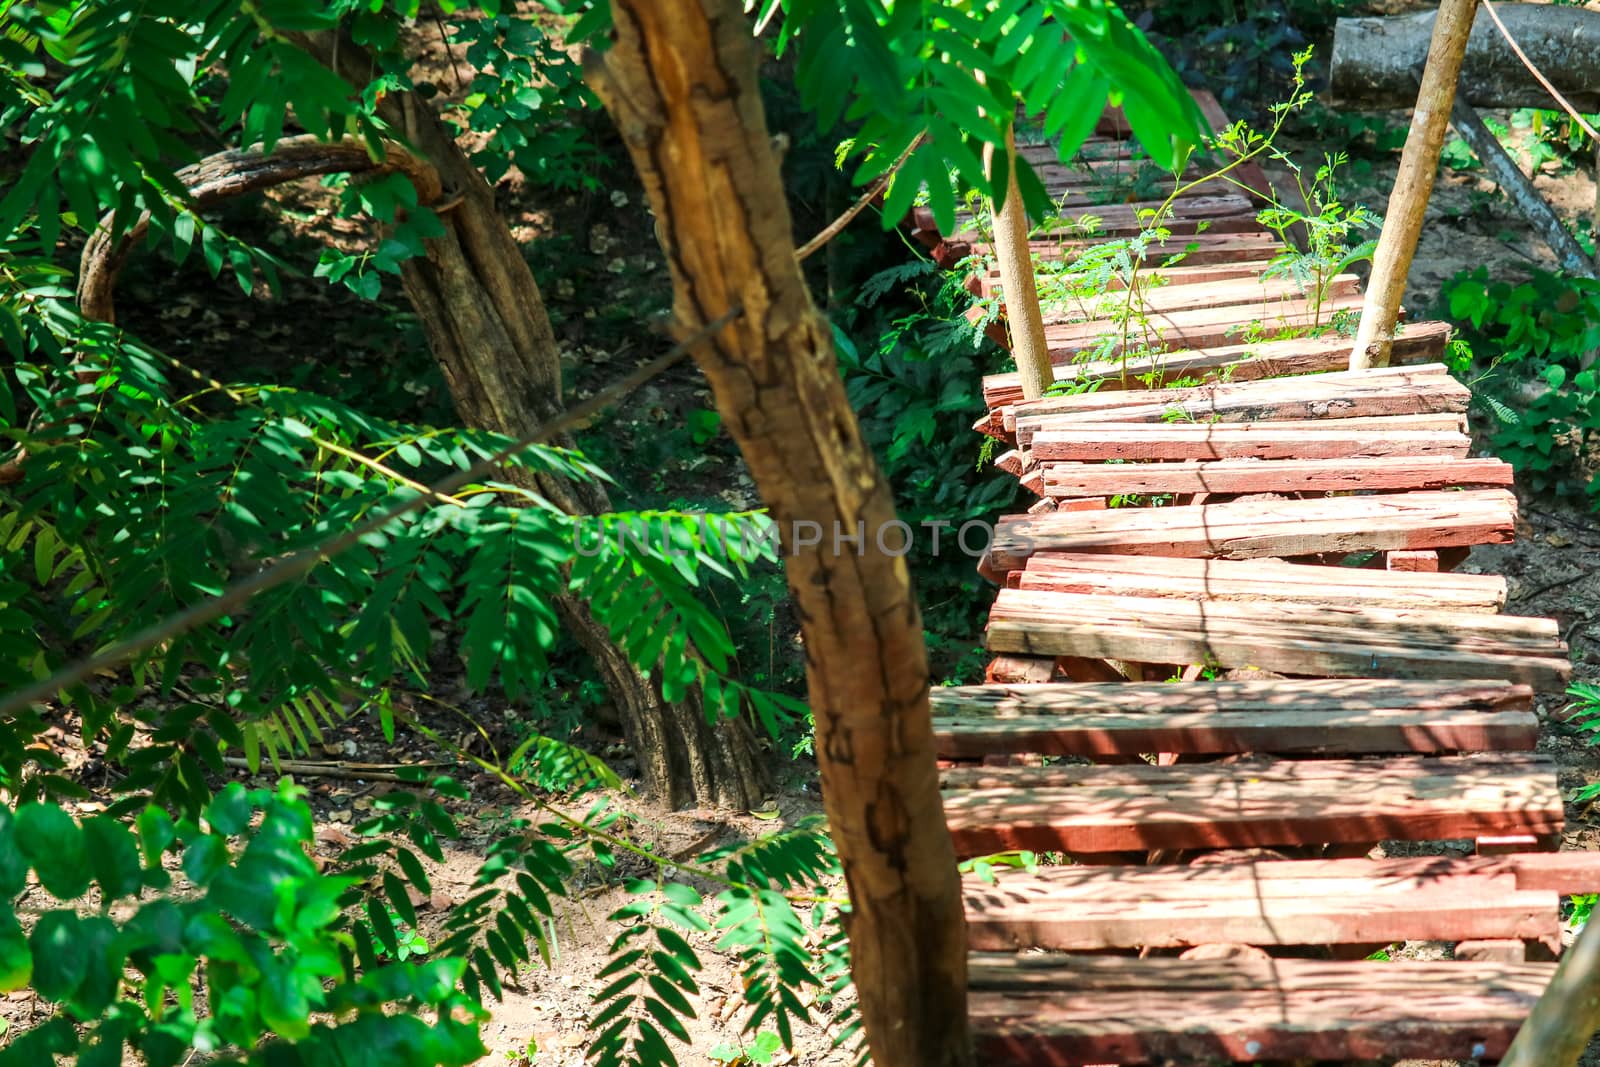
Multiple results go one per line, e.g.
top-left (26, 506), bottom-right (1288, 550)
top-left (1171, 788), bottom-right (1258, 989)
top-left (586, 0), bottom-right (973, 1067)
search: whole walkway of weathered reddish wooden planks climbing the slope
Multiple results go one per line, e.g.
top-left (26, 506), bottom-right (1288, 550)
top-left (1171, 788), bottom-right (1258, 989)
top-left (912, 94), bottom-right (1600, 1065)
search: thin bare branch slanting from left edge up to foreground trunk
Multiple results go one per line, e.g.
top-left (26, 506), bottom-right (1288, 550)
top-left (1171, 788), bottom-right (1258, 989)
top-left (0, 306), bottom-right (744, 718)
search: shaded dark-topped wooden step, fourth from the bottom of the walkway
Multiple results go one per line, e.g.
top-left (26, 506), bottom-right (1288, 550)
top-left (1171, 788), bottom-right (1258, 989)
top-left (933, 678), bottom-right (1539, 760)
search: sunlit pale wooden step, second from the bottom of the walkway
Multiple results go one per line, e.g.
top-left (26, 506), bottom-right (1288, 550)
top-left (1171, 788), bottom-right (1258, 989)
top-left (962, 857), bottom-right (1561, 952)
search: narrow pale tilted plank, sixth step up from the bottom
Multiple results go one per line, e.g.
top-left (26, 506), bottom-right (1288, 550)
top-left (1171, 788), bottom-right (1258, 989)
top-left (1013, 552), bottom-right (1506, 613)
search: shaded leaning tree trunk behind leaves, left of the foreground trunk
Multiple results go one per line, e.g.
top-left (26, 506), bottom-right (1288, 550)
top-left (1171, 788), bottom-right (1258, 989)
top-left (296, 35), bottom-right (768, 808)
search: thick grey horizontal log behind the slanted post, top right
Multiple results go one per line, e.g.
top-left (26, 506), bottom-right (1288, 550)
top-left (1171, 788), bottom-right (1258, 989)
top-left (1330, 3), bottom-right (1600, 114)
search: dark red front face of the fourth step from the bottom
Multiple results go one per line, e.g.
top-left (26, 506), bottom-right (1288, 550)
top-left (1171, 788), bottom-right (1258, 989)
top-left (933, 700), bottom-right (1539, 760)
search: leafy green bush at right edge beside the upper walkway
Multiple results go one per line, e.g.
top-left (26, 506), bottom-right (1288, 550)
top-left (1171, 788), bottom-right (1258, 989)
top-left (1443, 267), bottom-right (1600, 499)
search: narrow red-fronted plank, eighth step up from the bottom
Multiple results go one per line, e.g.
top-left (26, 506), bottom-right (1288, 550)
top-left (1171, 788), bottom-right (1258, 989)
top-left (1043, 456), bottom-right (1514, 498)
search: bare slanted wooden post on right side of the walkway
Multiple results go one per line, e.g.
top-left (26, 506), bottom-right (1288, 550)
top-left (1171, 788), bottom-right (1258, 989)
top-left (1350, 0), bottom-right (1478, 371)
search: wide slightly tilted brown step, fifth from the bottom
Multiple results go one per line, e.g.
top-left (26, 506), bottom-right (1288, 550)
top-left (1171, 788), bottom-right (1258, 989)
top-left (984, 589), bottom-right (1571, 691)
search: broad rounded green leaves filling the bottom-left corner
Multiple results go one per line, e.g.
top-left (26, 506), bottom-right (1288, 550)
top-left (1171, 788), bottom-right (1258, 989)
top-left (0, 784), bottom-right (485, 1067)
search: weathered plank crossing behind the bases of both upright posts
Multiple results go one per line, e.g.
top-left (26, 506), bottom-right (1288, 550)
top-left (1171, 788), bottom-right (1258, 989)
top-left (984, 322), bottom-right (1450, 410)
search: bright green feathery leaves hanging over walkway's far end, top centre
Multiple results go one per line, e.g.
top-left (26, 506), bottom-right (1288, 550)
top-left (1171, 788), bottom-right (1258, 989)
top-left (758, 0), bottom-right (1205, 234)
